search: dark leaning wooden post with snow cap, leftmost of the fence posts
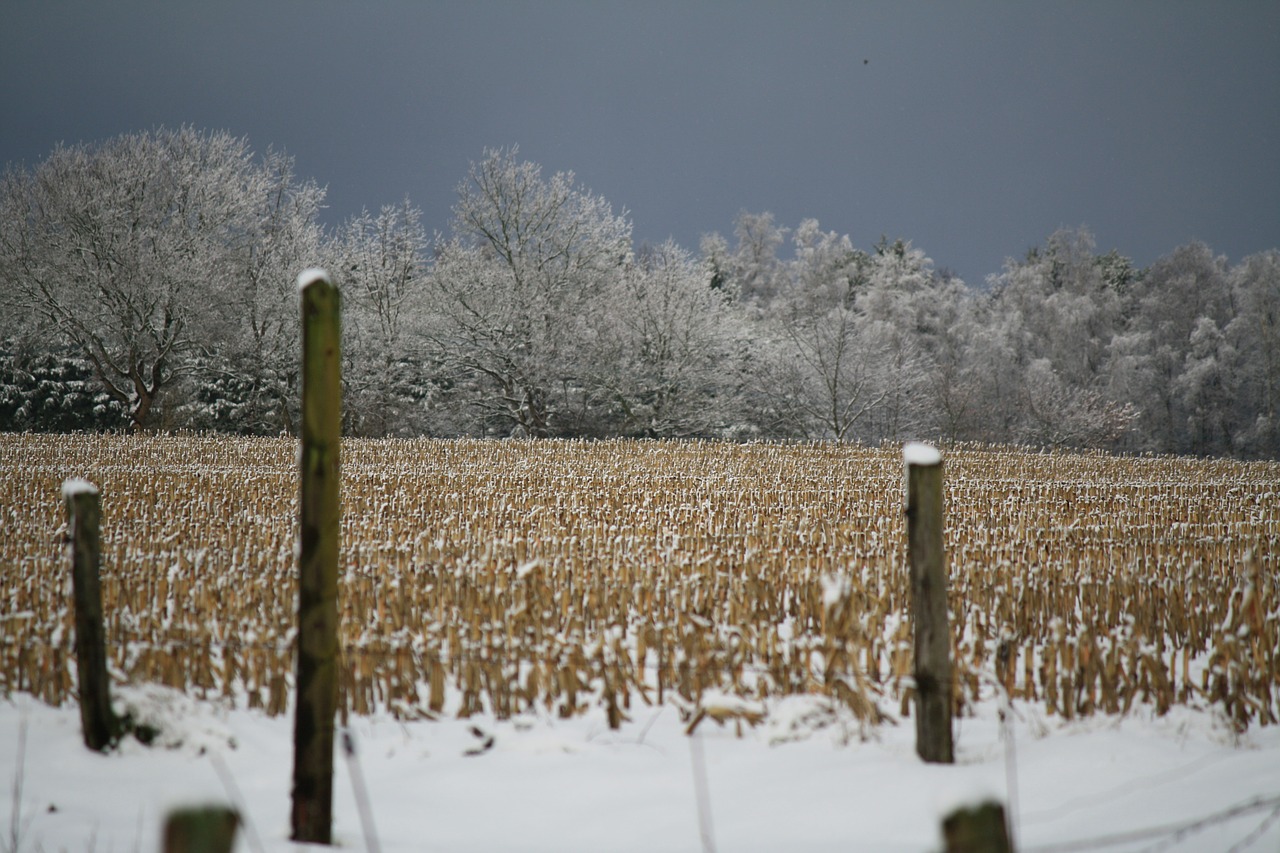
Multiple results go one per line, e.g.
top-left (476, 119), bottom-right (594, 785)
top-left (63, 479), bottom-right (120, 752)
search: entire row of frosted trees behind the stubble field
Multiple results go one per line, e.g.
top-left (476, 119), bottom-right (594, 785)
top-left (0, 127), bottom-right (1280, 459)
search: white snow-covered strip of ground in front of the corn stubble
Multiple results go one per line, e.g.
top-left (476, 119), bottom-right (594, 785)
top-left (0, 688), bottom-right (1280, 853)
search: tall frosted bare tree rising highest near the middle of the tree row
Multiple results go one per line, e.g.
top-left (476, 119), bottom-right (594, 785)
top-left (428, 149), bottom-right (631, 435)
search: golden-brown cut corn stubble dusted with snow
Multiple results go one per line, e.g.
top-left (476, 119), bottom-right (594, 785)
top-left (0, 435), bottom-right (1280, 730)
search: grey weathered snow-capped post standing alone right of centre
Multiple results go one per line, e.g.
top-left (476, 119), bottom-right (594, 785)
top-left (902, 442), bottom-right (955, 765)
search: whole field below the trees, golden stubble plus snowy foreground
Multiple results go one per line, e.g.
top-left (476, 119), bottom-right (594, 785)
top-left (0, 435), bottom-right (1280, 853)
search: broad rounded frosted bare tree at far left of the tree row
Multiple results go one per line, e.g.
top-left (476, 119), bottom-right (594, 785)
top-left (0, 127), bottom-right (319, 428)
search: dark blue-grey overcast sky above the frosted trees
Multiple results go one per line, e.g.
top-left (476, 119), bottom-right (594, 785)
top-left (0, 0), bottom-right (1280, 284)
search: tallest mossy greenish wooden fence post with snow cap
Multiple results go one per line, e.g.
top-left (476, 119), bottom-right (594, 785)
top-left (293, 269), bottom-right (342, 844)
